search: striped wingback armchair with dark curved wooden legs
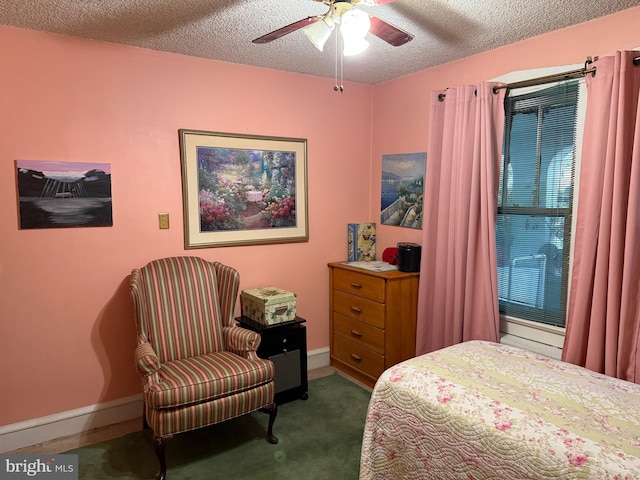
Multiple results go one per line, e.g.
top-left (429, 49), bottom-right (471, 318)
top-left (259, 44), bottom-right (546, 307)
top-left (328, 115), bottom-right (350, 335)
top-left (130, 257), bottom-right (278, 479)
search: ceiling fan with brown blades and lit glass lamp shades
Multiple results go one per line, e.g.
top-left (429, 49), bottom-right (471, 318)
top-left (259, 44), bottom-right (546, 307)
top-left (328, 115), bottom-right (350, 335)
top-left (253, 0), bottom-right (413, 56)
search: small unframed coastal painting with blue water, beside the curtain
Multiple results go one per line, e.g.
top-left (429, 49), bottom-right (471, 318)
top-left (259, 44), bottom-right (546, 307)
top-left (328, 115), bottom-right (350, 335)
top-left (380, 153), bottom-right (427, 228)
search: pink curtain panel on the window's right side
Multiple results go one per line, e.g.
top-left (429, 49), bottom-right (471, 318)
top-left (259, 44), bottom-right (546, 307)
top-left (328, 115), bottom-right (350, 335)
top-left (562, 52), bottom-right (640, 383)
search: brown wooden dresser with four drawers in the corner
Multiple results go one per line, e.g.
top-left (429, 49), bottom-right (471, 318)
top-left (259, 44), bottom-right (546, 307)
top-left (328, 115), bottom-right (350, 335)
top-left (329, 263), bottom-right (419, 386)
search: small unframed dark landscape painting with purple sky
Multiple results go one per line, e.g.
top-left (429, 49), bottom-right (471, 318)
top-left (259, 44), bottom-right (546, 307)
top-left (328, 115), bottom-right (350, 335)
top-left (16, 160), bottom-right (113, 229)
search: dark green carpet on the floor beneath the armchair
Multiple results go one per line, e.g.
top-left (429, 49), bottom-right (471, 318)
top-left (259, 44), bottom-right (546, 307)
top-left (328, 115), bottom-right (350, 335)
top-left (67, 374), bottom-right (371, 480)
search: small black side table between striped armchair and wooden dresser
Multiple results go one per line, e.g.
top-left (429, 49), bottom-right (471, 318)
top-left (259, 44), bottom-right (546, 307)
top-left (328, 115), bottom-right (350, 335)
top-left (236, 316), bottom-right (309, 405)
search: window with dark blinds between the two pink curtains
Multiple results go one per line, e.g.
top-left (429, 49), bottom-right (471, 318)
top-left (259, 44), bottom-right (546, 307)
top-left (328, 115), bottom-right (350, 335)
top-left (496, 81), bottom-right (581, 334)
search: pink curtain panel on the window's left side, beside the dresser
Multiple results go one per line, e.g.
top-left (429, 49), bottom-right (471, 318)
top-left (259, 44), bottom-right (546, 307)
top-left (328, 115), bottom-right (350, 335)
top-left (416, 83), bottom-right (505, 355)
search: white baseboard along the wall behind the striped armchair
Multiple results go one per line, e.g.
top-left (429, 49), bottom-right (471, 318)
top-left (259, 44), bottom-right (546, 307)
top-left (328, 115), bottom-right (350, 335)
top-left (0, 347), bottom-right (336, 453)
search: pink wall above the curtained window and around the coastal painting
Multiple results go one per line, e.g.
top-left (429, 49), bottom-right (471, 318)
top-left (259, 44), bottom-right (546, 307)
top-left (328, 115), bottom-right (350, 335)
top-left (370, 7), bottom-right (640, 251)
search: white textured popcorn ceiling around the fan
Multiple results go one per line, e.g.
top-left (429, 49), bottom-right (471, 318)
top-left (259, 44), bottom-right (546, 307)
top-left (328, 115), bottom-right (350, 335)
top-left (0, 0), bottom-right (640, 84)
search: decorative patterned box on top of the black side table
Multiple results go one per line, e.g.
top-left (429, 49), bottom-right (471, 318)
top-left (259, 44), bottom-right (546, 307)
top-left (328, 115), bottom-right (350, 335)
top-left (240, 287), bottom-right (296, 325)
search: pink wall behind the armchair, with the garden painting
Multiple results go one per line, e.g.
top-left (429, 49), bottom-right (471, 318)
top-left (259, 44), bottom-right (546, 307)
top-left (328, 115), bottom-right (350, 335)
top-left (0, 27), bottom-right (372, 425)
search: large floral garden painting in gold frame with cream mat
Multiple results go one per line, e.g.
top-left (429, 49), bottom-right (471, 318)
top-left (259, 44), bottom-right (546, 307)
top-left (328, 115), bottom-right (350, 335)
top-left (179, 129), bottom-right (309, 249)
